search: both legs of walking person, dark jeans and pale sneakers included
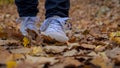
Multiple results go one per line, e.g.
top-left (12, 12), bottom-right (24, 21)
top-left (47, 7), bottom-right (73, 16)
top-left (15, 0), bottom-right (70, 42)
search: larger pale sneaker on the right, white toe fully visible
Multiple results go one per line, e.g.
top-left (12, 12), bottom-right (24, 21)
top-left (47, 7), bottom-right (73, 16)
top-left (40, 17), bottom-right (69, 42)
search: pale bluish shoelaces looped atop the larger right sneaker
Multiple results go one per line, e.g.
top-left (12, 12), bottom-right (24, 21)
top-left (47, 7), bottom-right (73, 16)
top-left (40, 17), bottom-right (70, 32)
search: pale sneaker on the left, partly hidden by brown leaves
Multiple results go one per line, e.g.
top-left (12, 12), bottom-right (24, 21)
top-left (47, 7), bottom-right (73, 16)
top-left (17, 17), bottom-right (38, 36)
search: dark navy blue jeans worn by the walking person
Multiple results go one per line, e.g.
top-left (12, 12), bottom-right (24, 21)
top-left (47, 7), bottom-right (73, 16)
top-left (15, 0), bottom-right (70, 18)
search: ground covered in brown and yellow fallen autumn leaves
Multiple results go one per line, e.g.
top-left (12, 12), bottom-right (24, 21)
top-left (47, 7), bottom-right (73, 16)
top-left (0, 0), bottom-right (120, 68)
